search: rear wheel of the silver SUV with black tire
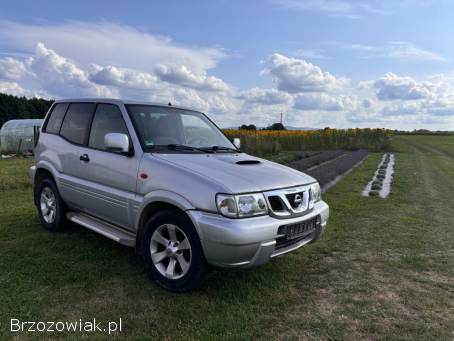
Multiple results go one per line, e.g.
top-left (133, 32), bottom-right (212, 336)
top-left (35, 178), bottom-right (68, 232)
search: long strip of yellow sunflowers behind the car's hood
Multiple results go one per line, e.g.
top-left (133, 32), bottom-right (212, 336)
top-left (224, 128), bottom-right (392, 156)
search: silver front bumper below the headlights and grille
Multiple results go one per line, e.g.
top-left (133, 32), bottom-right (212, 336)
top-left (187, 201), bottom-right (329, 267)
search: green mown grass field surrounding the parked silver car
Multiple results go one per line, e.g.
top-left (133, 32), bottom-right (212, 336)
top-left (0, 136), bottom-right (454, 341)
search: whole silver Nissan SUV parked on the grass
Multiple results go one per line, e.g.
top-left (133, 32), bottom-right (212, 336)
top-left (30, 99), bottom-right (329, 291)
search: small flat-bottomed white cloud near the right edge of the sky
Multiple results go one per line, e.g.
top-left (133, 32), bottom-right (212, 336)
top-left (373, 72), bottom-right (435, 101)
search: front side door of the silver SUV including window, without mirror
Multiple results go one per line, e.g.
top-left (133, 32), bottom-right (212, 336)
top-left (75, 103), bottom-right (139, 229)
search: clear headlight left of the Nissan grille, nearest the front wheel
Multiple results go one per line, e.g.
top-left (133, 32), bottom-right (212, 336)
top-left (216, 193), bottom-right (268, 218)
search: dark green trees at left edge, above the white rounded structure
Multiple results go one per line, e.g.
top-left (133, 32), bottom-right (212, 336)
top-left (0, 93), bottom-right (53, 127)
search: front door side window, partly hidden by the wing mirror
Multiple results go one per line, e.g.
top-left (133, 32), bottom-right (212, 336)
top-left (88, 104), bottom-right (129, 150)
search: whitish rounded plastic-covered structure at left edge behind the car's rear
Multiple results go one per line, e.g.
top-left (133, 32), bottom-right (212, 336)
top-left (0, 119), bottom-right (44, 154)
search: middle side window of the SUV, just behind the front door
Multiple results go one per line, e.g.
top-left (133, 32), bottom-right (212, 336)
top-left (60, 103), bottom-right (95, 144)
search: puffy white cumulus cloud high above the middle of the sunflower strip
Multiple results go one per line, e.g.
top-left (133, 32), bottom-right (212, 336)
top-left (265, 53), bottom-right (346, 93)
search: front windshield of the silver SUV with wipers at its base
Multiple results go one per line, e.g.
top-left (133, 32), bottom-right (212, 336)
top-left (127, 105), bottom-right (234, 151)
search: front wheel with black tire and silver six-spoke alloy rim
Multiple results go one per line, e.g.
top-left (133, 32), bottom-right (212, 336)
top-left (141, 210), bottom-right (208, 292)
